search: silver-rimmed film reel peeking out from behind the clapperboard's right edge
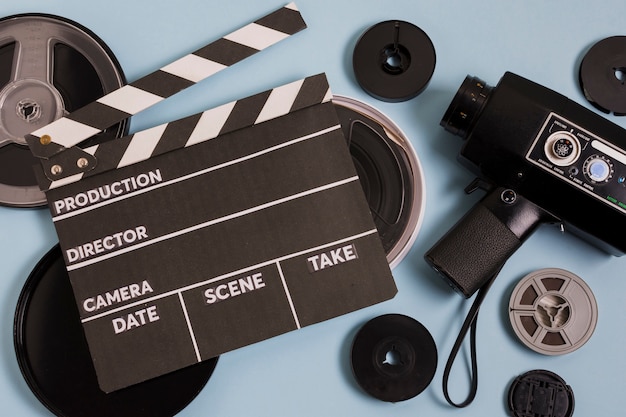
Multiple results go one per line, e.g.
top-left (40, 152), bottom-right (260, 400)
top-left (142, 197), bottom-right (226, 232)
top-left (333, 96), bottom-right (425, 268)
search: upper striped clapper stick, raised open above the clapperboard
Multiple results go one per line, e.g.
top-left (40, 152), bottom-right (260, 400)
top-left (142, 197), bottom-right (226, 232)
top-left (25, 3), bottom-right (306, 159)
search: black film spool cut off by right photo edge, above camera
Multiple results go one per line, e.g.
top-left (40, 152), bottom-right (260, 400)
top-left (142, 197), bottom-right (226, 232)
top-left (579, 36), bottom-right (626, 116)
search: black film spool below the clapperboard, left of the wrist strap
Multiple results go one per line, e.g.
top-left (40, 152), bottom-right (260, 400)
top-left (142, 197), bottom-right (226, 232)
top-left (352, 314), bottom-right (437, 402)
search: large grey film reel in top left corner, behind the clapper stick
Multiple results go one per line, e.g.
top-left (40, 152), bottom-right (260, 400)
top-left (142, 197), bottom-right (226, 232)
top-left (0, 14), bottom-right (127, 207)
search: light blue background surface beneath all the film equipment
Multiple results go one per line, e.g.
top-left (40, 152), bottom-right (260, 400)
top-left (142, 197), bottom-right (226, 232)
top-left (0, 0), bottom-right (626, 417)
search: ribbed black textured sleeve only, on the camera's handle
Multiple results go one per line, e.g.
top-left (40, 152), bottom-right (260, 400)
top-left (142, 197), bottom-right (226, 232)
top-left (424, 203), bottom-right (522, 298)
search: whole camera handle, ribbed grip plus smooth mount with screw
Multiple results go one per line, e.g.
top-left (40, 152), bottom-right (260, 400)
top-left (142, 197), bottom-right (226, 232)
top-left (424, 187), bottom-right (556, 298)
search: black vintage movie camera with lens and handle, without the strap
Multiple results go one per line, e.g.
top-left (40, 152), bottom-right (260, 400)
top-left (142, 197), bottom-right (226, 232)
top-left (425, 72), bottom-right (626, 297)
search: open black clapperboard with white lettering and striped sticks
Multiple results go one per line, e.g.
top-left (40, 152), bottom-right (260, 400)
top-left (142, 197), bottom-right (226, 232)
top-left (27, 4), bottom-right (397, 392)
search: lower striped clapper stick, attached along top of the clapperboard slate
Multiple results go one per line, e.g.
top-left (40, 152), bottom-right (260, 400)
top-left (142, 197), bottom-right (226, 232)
top-left (38, 74), bottom-right (332, 191)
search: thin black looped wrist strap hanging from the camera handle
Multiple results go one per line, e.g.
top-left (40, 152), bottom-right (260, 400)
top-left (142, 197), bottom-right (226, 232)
top-left (443, 267), bottom-right (501, 408)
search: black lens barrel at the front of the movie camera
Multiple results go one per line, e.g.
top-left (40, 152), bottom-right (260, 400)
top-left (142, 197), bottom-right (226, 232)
top-left (440, 75), bottom-right (493, 139)
